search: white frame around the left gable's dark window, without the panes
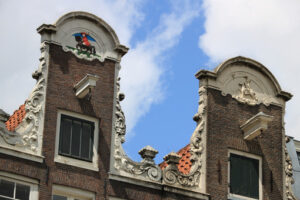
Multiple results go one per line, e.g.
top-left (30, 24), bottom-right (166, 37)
top-left (54, 110), bottom-right (99, 171)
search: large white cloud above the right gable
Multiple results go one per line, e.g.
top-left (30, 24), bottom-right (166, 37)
top-left (199, 0), bottom-right (300, 139)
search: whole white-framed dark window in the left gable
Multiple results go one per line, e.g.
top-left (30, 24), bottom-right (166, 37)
top-left (54, 110), bottom-right (99, 171)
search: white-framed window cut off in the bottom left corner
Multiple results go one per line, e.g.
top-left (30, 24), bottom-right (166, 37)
top-left (0, 172), bottom-right (37, 200)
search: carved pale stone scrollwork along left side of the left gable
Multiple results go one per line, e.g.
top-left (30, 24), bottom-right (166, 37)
top-left (0, 43), bottom-right (48, 156)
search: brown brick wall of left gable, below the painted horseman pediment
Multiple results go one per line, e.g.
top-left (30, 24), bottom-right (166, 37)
top-left (0, 44), bottom-right (205, 200)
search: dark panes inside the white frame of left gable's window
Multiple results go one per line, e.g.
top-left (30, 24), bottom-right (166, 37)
top-left (59, 115), bottom-right (94, 161)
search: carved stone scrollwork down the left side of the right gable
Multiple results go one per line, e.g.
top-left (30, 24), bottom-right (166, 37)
top-left (163, 86), bottom-right (207, 188)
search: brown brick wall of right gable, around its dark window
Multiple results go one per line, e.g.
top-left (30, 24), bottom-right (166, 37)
top-left (207, 89), bottom-right (283, 200)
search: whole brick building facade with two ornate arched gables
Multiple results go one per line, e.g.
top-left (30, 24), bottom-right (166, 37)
top-left (0, 12), bottom-right (296, 200)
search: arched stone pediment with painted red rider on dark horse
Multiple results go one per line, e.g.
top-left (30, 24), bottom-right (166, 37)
top-left (37, 12), bottom-right (128, 62)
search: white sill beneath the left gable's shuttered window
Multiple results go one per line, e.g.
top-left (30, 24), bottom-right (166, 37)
top-left (54, 155), bottom-right (99, 171)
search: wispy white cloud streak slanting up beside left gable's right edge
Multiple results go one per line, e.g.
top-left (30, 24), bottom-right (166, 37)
top-left (121, 1), bottom-right (201, 138)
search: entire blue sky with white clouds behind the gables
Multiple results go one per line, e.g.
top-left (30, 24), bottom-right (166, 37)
top-left (0, 0), bottom-right (300, 162)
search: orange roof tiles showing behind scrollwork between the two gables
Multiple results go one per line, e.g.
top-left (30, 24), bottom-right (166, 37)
top-left (159, 144), bottom-right (192, 174)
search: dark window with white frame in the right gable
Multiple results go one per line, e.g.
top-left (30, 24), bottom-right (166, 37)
top-left (228, 152), bottom-right (262, 199)
